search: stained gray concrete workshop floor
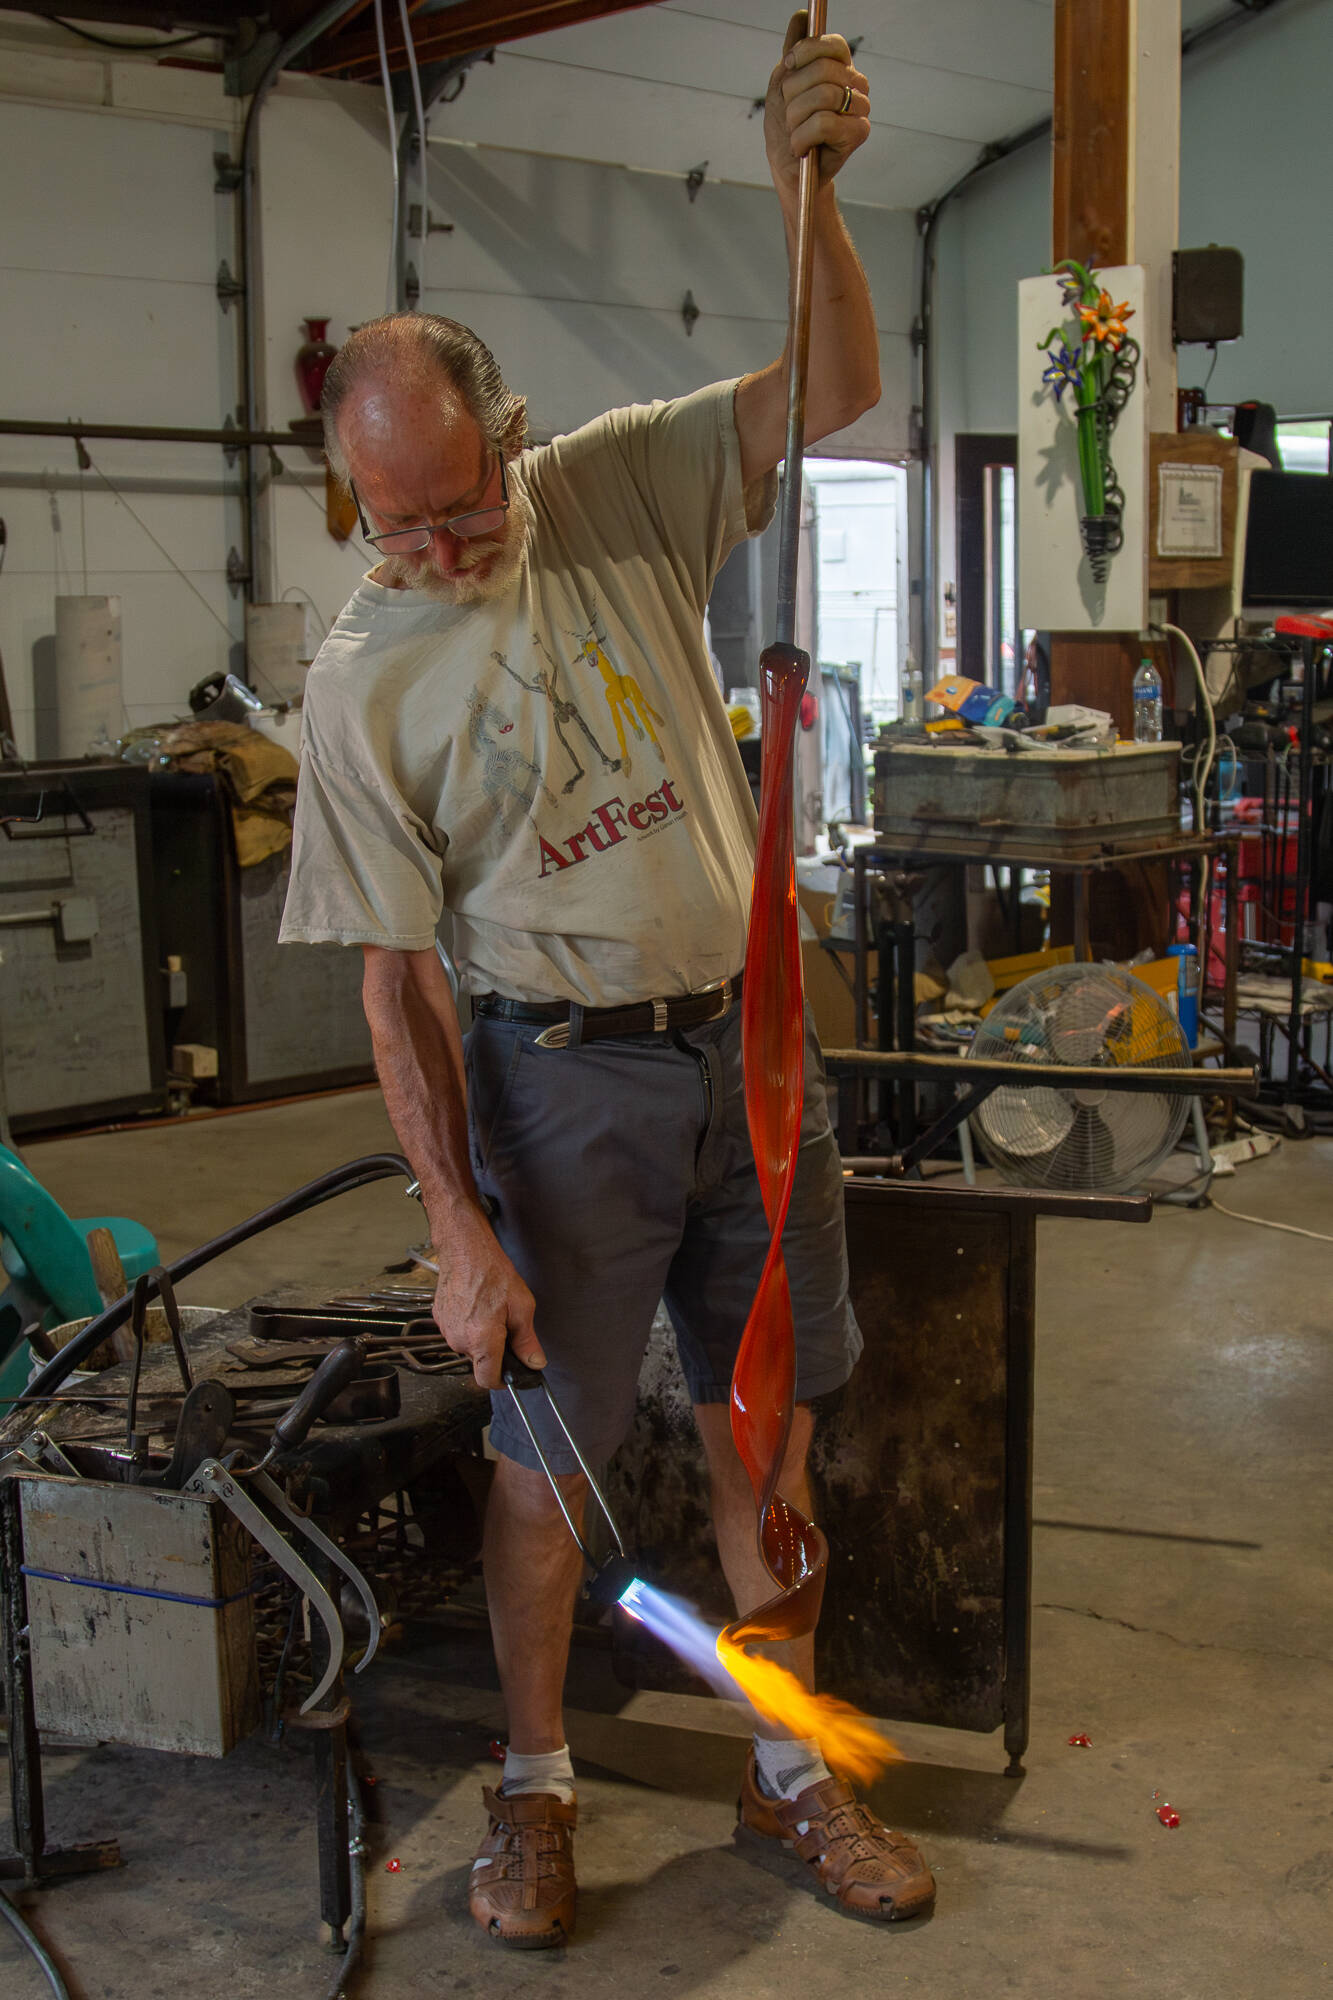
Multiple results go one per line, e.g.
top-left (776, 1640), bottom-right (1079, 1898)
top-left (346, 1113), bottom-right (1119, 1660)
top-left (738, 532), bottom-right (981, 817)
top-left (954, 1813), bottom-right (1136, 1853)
top-left (0, 1094), bottom-right (1333, 2000)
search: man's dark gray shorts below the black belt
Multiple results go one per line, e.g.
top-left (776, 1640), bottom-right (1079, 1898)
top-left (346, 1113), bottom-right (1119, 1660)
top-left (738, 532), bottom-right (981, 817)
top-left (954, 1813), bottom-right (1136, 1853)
top-left (466, 1006), bottom-right (861, 1472)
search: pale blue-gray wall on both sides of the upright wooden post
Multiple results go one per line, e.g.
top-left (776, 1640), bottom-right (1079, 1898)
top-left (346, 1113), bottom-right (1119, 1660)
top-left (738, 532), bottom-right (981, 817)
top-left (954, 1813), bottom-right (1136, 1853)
top-left (937, 0), bottom-right (1333, 656)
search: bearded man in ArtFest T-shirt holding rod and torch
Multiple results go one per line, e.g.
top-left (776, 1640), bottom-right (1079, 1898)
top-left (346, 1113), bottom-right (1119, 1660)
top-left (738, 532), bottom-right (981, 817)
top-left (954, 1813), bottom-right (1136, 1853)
top-left (284, 16), bottom-right (935, 1946)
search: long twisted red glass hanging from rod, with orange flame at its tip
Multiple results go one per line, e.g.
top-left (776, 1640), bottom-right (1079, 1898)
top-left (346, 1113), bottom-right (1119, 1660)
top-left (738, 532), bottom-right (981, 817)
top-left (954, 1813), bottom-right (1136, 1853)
top-left (717, 646), bottom-right (897, 1778)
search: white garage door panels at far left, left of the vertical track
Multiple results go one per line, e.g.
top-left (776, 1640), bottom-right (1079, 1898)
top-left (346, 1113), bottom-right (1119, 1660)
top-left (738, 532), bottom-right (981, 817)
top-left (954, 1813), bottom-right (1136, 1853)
top-left (0, 76), bottom-right (240, 750)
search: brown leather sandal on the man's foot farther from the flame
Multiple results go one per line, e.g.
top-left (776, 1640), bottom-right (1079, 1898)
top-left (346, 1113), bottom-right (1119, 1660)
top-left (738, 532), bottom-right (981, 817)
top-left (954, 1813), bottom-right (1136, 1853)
top-left (468, 1784), bottom-right (578, 1952)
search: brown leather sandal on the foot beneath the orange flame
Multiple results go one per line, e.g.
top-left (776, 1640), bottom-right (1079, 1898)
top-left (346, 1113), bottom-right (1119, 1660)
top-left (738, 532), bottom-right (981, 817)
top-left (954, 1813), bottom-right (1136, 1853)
top-left (737, 1748), bottom-right (935, 1924)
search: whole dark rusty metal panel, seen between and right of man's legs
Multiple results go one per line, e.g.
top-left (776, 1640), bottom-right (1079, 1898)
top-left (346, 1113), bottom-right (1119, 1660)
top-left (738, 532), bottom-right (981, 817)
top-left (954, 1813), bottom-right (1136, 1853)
top-left (608, 1186), bottom-right (1031, 1730)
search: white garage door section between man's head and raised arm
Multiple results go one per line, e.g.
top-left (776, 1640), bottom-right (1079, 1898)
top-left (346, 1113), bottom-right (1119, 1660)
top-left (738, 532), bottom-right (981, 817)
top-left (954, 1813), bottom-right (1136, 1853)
top-left (424, 132), bottom-right (915, 458)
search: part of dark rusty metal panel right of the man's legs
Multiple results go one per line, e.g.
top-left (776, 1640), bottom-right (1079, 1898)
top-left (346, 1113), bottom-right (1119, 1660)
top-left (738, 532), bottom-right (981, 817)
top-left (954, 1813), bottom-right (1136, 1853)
top-left (813, 1198), bottom-right (1011, 1730)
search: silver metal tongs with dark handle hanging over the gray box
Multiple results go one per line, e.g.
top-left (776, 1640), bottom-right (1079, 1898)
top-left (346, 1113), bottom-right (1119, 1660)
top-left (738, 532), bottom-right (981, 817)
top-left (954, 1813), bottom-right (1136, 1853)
top-left (180, 1338), bottom-right (384, 1716)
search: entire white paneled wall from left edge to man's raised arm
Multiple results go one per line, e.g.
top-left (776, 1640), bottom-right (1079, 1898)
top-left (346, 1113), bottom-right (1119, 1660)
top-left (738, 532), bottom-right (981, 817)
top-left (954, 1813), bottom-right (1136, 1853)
top-left (0, 41), bottom-right (915, 754)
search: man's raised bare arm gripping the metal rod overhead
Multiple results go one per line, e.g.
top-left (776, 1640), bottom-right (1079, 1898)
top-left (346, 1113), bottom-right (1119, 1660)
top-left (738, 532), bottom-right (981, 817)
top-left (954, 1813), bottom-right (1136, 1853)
top-left (737, 14), bottom-right (879, 484)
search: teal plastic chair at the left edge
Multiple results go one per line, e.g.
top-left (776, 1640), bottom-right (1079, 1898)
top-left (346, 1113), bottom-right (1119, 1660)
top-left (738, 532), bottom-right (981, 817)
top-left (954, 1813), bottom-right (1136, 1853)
top-left (0, 1146), bottom-right (162, 1410)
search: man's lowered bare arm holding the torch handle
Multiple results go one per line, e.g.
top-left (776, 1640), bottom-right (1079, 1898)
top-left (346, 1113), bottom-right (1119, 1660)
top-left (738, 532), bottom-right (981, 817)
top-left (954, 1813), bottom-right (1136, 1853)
top-left (362, 944), bottom-right (544, 1388)
